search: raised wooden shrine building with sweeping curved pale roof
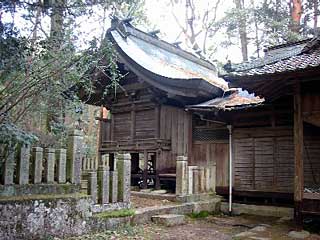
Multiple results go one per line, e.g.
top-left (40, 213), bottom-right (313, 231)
top-left (81, 19), bottom-right (228, 191)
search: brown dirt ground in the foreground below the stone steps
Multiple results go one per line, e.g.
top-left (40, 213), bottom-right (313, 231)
top-left (65, 215), bottom-right (320, 240)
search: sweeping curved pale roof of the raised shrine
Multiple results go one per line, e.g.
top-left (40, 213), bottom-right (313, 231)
top-left (107, 17), bottom-right (228, 97)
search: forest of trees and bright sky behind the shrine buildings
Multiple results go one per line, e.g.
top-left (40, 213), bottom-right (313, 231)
top-left (0, 0), bottom-right (320, 161)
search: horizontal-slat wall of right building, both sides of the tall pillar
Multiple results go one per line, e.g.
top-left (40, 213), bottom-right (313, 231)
top-left (233, 127), bottom-right (320, 193)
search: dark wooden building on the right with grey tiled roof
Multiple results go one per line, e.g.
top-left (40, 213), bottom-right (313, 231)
top-left (190, 38), bottom-right (320, 223)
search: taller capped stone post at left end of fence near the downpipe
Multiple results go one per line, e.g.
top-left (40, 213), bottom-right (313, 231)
top-left (176, 156), bottom-right (188, 196)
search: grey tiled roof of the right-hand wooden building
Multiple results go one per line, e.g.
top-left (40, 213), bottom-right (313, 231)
top-left (224, 37), bottom-right (320, 100)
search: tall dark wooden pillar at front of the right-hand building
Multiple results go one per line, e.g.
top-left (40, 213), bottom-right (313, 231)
top-left (293, 82), bottom-right (304, 227)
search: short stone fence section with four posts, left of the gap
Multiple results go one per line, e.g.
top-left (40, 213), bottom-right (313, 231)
top-left (88, 154), bottom-right (131, 209)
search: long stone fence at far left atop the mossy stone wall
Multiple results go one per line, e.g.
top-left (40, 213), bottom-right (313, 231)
top-left (0, 130), bottom-right (83, 196)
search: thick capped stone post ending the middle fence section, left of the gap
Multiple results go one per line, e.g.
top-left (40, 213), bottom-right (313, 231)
top-left (116, 154), bottom-right (131, 203)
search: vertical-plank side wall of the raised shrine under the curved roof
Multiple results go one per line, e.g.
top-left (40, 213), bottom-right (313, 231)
top-left (159, 105), bottom-right (192, 170)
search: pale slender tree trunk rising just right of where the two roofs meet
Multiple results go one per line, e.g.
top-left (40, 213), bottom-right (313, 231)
top-left (235, 0), bottom-right (248, 61)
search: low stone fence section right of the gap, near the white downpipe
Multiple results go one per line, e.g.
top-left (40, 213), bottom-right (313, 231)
top-left (176, 156), bottom-right (216, 196)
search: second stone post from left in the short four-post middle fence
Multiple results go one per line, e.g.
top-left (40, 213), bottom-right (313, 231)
top-left (98, 165), bottom-right (110, 204)
